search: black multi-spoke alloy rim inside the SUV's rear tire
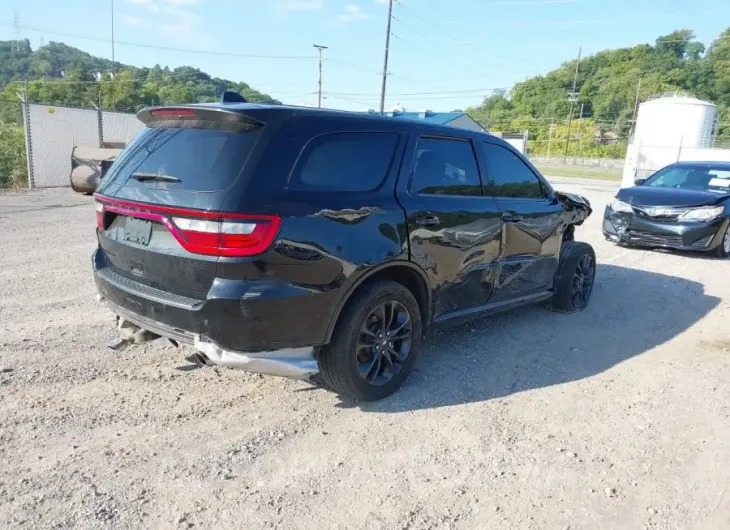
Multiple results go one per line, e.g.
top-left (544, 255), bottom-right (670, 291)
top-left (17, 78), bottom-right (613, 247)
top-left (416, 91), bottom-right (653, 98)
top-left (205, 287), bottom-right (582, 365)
top-left (355, 300), bottom-right (413, 386)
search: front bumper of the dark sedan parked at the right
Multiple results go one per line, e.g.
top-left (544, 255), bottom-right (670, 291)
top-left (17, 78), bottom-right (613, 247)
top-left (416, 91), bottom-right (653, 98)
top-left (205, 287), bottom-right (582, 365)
top-left (603, 206), bottom-right (728, 251)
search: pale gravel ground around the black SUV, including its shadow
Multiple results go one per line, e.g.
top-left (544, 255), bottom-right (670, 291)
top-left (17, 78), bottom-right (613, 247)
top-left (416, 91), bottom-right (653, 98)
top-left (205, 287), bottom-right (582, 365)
top-left (0, 180), bottom-right (730, 529)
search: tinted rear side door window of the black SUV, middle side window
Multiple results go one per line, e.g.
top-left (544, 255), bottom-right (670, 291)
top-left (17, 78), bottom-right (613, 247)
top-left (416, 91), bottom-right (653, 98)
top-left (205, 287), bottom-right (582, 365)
top-left (411, 138), bottom-right (482, 195)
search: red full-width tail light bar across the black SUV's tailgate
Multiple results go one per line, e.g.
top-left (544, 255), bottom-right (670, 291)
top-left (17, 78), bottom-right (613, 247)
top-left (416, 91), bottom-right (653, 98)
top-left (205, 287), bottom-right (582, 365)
top-left (97, 197), bottom-right (281, 257)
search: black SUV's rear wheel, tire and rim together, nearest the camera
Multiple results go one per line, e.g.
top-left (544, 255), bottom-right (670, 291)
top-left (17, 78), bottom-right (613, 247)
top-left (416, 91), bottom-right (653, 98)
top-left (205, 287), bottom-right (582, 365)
top-left (318, 281), bottom-right (423, 401)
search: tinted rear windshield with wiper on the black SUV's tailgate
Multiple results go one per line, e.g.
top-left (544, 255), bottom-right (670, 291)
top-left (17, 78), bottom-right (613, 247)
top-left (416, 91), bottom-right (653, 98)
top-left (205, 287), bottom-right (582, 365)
top-left (101, 128), bottom-right (261, 191)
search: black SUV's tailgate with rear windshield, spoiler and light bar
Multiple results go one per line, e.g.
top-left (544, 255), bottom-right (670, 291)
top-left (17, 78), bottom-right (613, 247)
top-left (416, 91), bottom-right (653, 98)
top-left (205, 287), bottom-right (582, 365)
top-left (97, 107), bottom-right (267, 299)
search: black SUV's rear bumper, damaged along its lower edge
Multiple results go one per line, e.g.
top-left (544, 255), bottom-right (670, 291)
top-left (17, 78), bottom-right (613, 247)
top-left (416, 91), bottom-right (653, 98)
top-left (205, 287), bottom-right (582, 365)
top-left (92, 251), bottom-right (333, 354)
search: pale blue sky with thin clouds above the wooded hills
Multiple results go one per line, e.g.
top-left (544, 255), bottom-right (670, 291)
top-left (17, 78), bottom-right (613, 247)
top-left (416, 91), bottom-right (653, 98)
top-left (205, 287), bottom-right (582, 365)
top-left (0, 0), bottom-right (730, 112)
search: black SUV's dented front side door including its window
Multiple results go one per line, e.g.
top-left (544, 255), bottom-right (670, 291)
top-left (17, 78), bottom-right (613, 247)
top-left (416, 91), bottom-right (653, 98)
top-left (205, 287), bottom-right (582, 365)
top-left (480, 140), bottom-right (564, 301)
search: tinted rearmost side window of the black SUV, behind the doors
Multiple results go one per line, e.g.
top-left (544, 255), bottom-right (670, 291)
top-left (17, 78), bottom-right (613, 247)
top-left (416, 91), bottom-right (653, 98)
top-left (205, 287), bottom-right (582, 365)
top-left (290, 133), bottom-right (398, 191)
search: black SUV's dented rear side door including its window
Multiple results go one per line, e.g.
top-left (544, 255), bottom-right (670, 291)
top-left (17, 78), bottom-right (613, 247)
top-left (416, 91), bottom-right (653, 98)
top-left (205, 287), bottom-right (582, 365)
top-left (398, 136), bottom-right (502, 321)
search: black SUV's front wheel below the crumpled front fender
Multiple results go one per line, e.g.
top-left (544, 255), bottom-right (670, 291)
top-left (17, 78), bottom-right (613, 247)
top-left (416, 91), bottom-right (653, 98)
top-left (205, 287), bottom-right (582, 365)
top-left (552, 241), bottom-right (596, 313)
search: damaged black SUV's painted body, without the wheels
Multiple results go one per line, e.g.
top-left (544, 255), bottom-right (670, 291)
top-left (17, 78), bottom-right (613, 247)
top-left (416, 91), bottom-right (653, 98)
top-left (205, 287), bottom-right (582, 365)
top-left (92, 100), bottom-right (591, 388)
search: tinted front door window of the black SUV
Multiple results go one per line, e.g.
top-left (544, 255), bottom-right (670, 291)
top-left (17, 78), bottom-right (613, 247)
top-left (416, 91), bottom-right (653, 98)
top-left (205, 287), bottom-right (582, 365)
top-left (482, 143), bottom-right (544, 199)
